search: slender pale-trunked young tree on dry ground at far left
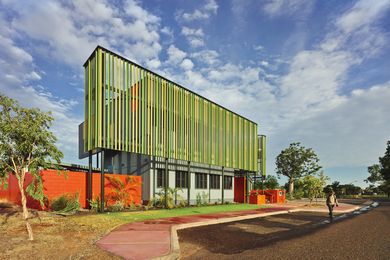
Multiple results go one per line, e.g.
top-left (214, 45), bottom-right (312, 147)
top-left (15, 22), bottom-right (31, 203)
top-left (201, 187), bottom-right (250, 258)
top-left (0, 94), bottom-right (63, 240)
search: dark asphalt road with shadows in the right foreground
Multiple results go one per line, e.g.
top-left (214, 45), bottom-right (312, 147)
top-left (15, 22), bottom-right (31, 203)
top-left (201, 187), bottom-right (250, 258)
top-left (178, 201), bottom-right (390, 259)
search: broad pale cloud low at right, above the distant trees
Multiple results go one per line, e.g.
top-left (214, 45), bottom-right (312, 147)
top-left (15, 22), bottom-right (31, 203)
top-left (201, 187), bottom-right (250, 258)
top-left (274, 82), bottom-right (390, 167)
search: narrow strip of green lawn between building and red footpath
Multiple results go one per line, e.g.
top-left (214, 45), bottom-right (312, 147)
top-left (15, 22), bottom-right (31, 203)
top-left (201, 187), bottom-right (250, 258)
top-left (71, 204), bottom-right (265, 229)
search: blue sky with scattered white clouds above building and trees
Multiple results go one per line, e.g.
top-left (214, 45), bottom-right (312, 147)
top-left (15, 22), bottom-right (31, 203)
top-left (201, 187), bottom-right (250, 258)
top-left (0, 0), bottom-right (390, 186)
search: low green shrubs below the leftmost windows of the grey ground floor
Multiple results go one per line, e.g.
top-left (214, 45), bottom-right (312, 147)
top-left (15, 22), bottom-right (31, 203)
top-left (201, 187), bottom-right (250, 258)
top-left (149, 187), bottom-right (186, 209)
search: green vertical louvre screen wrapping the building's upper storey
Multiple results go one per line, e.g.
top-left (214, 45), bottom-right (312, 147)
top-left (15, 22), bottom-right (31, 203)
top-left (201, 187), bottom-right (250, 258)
top-left (83, 47), bottom-right (258, 172)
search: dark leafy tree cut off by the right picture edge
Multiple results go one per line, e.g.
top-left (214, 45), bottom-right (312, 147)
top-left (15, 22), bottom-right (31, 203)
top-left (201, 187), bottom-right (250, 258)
top-left (365, 141), bottom-right (390, 197)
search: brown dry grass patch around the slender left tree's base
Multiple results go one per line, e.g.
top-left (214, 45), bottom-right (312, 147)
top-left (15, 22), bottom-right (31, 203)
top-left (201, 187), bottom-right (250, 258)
top-left (0, 203), bottom-right (116, 259)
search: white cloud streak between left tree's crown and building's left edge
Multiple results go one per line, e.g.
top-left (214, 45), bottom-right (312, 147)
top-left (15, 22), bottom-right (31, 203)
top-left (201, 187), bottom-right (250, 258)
top-left (0, 31), bottom-right (82, 162)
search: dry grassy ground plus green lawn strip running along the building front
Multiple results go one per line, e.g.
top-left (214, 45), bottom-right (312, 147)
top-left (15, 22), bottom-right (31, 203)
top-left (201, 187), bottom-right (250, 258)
top-left (0, 202), bottom-right (264, 259)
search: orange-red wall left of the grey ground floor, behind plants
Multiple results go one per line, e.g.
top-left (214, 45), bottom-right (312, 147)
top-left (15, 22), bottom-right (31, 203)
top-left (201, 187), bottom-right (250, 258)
top-left (0, 170), bottom-right (142, 208)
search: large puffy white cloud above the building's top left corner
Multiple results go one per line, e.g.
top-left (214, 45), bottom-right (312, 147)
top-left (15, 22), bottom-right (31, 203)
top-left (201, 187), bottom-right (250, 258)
top-left (5, 0), bottom-right (161, 66)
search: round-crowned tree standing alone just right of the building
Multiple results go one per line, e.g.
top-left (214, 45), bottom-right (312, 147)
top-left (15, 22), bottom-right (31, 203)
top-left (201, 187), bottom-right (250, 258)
top-left (276, 143), bottom-right (322, 196)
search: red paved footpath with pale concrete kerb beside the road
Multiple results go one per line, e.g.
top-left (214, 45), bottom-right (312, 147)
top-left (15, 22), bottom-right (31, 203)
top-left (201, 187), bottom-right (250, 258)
top-left (97, 203), bottom-right (358, 260)
